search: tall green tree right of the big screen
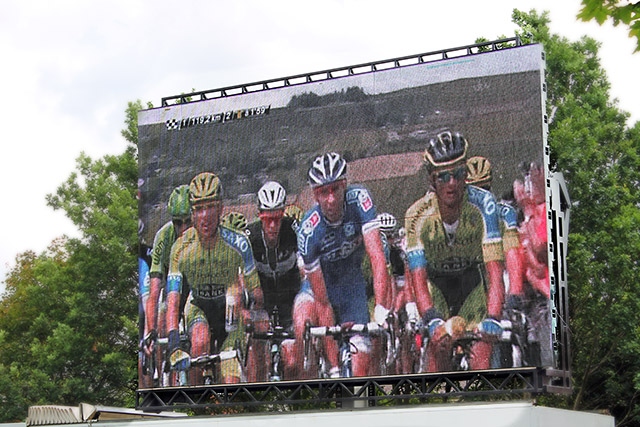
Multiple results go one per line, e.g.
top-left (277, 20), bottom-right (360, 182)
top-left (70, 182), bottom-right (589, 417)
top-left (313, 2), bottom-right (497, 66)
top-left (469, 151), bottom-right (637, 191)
top-left (513, 11), bottom-right (640, 425)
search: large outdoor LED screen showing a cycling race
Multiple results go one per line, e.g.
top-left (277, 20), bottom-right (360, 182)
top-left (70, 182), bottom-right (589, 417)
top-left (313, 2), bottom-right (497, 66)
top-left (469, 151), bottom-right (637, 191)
top-left (139, 45), bottom-right (554, 388)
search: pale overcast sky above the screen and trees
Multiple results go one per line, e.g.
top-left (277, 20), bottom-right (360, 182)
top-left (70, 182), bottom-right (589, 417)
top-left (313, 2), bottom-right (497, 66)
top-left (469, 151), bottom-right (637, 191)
top-left (0, 0), bottom-right (640, 291)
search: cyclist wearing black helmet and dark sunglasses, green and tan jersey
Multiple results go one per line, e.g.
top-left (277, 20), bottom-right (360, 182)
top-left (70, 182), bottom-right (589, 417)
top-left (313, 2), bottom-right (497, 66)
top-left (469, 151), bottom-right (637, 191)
top-left (405, 129), bottom-right (504, 371)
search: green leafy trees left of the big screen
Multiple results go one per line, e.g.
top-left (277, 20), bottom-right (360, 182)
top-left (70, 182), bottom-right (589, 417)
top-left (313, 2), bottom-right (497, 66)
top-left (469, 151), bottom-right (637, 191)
top-left (0, 101), bottom-right (142, 421)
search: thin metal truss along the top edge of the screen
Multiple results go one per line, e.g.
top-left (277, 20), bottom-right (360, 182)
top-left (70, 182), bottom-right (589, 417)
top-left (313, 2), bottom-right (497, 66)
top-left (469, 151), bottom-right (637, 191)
top-left (161, 37), bottom-right (522, 107)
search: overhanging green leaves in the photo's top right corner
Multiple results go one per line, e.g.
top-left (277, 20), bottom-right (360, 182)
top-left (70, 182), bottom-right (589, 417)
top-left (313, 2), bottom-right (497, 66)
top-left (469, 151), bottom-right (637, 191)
top-left (578, 0), bottom-right (640, 52)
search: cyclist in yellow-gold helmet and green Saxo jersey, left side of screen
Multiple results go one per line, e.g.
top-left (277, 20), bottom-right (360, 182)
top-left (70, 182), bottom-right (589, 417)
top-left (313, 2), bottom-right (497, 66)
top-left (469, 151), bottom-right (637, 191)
top-left (167, 172), bottom-right (262, 384)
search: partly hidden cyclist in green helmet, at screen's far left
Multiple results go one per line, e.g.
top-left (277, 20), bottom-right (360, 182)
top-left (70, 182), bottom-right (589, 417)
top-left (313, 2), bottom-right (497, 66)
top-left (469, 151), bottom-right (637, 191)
top-left (144, 185), bottom-right (191, 386)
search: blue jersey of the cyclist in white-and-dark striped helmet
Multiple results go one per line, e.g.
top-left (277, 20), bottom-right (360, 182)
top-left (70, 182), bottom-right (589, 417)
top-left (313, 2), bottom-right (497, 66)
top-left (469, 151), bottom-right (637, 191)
top-left (298, 186), bottom-right (380, 323)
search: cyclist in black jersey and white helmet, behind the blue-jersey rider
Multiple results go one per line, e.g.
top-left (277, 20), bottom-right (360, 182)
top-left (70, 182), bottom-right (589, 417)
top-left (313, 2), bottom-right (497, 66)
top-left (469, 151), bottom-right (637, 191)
top-left (246, 181), bottom-right (300, 378)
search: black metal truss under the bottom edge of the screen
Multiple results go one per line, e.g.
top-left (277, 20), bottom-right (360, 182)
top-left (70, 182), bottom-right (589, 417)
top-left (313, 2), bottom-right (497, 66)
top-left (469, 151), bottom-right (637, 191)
top-left (136, 368), bottom-right (550, 413)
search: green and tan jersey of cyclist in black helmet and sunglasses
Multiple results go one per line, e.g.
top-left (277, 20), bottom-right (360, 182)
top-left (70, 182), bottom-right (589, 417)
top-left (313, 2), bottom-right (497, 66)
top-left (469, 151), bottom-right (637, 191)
top-left (405, 186), bottom-right (504, 318)
